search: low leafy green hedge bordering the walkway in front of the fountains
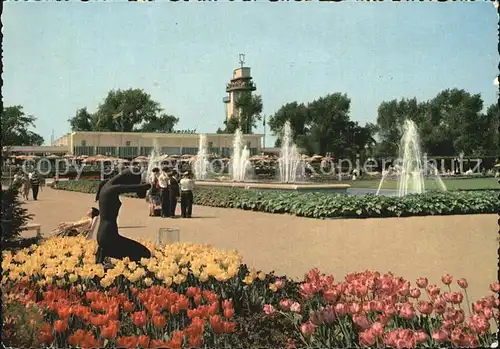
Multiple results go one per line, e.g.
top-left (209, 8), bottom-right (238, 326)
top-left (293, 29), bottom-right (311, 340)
top-left (48, 180), bottom-right (500, 218)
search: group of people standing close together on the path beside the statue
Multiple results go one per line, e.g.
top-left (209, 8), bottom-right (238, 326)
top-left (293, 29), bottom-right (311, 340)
top-left (147, 167), bottom-right (194, 218)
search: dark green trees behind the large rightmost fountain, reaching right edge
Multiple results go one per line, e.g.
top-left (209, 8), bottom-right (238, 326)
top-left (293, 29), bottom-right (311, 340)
top-left (377, 89), bottom-right (499, 156)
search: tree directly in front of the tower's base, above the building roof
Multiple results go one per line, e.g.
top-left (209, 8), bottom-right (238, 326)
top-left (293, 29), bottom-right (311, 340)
top-left (217, 91), bottom-right (263, 133)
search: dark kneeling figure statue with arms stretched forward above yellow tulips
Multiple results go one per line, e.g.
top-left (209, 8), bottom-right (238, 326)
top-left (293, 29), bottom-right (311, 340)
top-left (96, 168), bottom-right (151, 264)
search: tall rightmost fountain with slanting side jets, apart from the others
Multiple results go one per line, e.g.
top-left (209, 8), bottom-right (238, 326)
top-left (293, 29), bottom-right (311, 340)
top-left (375, 120), bottom-right (446, 196)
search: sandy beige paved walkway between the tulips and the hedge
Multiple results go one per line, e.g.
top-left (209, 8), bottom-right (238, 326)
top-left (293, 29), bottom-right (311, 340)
top-left (21, 188), bottom-right (498, 299)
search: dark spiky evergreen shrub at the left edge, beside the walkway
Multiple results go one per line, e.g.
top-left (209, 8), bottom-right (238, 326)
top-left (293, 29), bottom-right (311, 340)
top-left (1, 187), bottom-right (33, 245)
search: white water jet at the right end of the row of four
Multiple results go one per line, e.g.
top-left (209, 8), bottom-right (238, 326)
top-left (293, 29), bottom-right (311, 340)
top-left (278, 121), bottom-right (305, 183)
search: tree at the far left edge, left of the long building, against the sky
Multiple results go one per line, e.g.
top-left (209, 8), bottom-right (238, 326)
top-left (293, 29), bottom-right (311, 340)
top-left (1, 105), bottom-right (44, 146)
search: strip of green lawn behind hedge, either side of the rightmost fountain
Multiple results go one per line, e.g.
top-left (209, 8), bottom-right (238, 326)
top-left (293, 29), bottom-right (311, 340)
top-left (342, 178), bottom-right (500, 190)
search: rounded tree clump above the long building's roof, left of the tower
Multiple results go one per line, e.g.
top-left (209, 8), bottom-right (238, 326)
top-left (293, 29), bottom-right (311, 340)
top-left (68, 89), bottom-right (179, 132)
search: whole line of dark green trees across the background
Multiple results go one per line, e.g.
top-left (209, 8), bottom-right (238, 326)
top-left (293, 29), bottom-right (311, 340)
top-left (2, 88), bottom-right (500, 158)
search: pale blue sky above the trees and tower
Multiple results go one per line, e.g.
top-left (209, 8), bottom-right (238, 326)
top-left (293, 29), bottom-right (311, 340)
top-left (2, 1), bottom-right (499, 145)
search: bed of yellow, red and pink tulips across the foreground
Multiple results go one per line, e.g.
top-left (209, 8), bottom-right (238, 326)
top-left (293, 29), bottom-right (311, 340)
top-left (2, 237), bottom-right (500, 349)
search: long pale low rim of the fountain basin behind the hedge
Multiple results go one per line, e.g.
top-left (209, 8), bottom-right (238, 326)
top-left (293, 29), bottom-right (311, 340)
top-left (196, 181), bottom-right (351, 194)
